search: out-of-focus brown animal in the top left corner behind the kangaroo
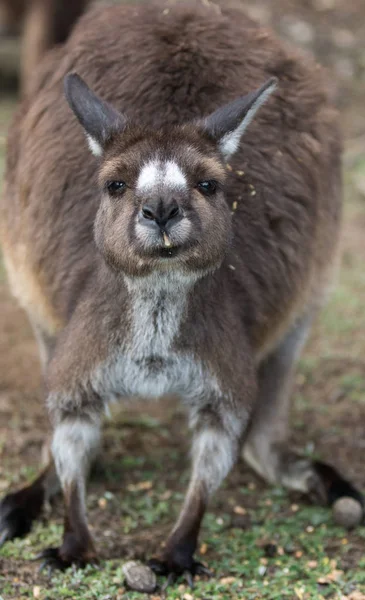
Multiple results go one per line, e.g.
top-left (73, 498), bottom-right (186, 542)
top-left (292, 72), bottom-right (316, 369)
top-left (0, 0), bottom-right (89, 93)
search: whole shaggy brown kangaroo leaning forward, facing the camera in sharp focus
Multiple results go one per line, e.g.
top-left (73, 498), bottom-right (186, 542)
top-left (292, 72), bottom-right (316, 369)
top-left (0, 2), bottom-right (363, 581)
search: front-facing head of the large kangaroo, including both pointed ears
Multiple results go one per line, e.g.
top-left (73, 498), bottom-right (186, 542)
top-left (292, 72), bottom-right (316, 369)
top-left (65, 73), bottom-right (276, 276)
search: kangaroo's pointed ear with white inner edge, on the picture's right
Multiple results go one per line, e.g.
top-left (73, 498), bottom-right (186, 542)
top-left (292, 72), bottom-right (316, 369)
top-left (201, 77), bottom-right (277, 160)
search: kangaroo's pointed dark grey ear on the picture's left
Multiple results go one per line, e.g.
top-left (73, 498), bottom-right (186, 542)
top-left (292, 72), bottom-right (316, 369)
top-left (64, 73), bottom-right (127, 156)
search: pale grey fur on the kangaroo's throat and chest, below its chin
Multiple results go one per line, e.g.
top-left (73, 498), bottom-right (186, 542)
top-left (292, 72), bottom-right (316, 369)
top-left (94, 273), bottom-right (219, 402)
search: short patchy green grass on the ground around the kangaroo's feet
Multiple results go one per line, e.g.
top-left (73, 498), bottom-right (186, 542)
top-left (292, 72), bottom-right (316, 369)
top-left (0, 488), bottom-right (365, 600)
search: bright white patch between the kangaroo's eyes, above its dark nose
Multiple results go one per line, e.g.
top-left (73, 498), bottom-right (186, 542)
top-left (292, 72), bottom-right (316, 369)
top-left (137, 160), bottom-right (188, 192)
